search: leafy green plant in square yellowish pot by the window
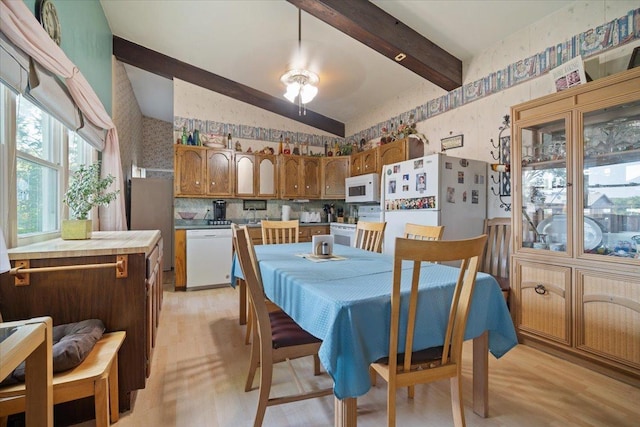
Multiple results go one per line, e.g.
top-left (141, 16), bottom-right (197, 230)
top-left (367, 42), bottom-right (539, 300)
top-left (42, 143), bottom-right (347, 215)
top-left (61, 162), bottom-right (120, 240)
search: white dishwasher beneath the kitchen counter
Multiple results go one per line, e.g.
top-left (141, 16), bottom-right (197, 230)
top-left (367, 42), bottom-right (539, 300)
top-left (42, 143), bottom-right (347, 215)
top-left (187, 228), bottom-right (233, 289)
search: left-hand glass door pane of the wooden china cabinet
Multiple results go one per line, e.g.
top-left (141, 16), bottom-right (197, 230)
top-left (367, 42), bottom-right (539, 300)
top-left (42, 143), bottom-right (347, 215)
top-left (519, 116), bottom-right (571, 252)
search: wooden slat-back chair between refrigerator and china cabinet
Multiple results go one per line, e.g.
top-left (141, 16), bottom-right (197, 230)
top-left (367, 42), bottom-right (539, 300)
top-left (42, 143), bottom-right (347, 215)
top-left (480, 217), bottom-right (511, 304)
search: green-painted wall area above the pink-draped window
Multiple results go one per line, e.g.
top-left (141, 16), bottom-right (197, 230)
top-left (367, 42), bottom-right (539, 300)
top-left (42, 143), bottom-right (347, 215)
top-left (24, 0), bottom-right (113, 115)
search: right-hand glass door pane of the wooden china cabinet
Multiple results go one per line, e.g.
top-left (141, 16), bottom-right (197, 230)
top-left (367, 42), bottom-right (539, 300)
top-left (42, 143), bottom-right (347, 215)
top-left (576, 101), bottom-right (640, 259)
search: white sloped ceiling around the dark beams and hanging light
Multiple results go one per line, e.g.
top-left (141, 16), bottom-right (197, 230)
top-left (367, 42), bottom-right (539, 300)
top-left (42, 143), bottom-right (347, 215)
top-left (100, 0), bottom-right (572, 127)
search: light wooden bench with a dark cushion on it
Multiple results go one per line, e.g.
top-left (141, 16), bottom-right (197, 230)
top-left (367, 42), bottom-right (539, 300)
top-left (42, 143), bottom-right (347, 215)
top-left (0, 331), bottom-right (125, 427)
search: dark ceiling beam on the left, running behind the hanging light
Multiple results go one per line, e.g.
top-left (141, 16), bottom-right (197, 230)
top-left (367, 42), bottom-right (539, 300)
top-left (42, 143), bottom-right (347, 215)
top-left (113, 36), bottom-right (345, 137)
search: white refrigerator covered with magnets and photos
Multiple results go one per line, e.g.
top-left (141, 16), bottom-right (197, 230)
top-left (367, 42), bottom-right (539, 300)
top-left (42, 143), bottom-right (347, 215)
top-left (380, 153), bottom-right (487, 255)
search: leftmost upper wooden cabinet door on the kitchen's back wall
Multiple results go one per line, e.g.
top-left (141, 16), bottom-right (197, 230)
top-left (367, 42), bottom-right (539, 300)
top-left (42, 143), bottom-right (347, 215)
top-left (175, 146), bottom-right (206, 196)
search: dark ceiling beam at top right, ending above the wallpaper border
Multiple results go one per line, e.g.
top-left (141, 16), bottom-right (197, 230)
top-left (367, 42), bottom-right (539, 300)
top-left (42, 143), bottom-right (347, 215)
top-left (288, 0), bottom-right (462, 91)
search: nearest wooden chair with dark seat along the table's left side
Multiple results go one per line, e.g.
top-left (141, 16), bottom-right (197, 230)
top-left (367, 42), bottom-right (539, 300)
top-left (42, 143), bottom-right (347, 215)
top-left (231, 228), bottom-right (333, 427)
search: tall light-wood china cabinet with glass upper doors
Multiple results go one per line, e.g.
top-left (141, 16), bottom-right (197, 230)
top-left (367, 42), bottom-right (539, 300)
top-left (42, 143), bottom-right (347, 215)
top-left (511, 68), bottom-right (640, 385)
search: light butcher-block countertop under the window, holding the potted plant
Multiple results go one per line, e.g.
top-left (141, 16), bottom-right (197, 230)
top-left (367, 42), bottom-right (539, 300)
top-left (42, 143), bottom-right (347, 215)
top-left (8, 230), bottom-right (160, 260)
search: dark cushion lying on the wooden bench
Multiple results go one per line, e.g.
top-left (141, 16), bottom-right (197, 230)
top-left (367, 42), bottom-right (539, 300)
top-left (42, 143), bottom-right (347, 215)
top-left (0, 319), bottom-right (105, 386)
